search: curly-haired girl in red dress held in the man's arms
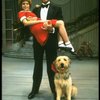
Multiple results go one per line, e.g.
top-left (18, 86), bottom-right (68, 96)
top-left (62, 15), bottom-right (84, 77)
top-left (18, 0), bottom-right (74, 52)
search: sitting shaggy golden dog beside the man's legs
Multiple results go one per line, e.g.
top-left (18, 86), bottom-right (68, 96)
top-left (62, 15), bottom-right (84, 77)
top-left (52, 56), bottom-right (77, 100)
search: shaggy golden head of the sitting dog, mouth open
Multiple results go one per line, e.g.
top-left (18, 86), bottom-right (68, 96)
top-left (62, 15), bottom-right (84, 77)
top-left (53, 56), bottom-right (71, 73)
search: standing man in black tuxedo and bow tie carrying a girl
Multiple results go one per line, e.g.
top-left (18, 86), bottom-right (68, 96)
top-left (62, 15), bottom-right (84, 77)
top-left (28, 0), bottom-right (63, 100)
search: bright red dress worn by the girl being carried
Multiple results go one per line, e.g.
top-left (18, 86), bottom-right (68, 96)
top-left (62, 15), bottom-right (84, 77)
top-left (18, 11), bottom-right (57, 46)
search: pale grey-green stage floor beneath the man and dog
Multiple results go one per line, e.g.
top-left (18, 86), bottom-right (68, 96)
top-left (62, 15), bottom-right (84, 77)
top-left (2, 57), bottom-right (99, 100)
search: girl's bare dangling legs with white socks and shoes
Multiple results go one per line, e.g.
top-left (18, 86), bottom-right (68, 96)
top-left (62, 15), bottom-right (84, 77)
top-left (56, 20), bottom-right (75, 52)
